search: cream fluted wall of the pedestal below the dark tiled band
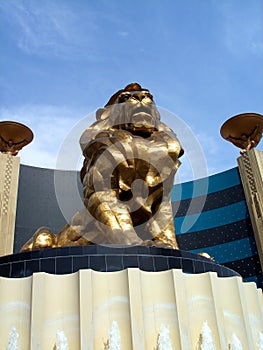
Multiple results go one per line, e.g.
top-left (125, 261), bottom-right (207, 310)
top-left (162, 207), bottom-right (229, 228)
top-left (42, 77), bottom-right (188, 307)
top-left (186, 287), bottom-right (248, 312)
top-left (0, 269), bottom-right (263, 350)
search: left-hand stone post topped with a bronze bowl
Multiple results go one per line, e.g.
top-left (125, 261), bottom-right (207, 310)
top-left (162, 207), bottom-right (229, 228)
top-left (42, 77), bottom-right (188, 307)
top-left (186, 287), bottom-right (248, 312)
top-left (0, 121), bottom-right (33, 256)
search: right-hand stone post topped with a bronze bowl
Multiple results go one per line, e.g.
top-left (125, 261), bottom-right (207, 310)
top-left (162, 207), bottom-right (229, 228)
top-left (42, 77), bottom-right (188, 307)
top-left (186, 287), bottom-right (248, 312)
top-left (220, 113), bottom-right (263, 269)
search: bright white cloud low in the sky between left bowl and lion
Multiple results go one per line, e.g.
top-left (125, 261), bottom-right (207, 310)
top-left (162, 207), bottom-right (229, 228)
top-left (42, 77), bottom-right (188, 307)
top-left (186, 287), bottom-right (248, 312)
top-left (0, 105), bottom-right (95, 170)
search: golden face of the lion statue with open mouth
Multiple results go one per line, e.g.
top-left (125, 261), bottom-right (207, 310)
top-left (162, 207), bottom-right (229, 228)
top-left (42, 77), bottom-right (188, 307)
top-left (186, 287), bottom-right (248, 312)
top-left (98, 90), bottom-right (160, 136)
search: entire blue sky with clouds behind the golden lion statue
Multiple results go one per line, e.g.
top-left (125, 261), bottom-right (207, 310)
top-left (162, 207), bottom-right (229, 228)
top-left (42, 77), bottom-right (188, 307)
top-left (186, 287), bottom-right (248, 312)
top-left (0, 0), bottom-right (263, 181)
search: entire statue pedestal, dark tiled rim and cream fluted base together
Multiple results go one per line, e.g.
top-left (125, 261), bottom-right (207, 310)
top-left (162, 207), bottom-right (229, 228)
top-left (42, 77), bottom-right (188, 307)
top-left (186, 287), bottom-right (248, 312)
top-left (0, 245), bottom-right (263, 350)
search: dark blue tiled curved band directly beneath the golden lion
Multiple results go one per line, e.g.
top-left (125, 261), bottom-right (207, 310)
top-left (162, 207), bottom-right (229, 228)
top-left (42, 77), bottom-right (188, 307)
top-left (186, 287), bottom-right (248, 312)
top-left (0, 245), bottom-right (239, 278)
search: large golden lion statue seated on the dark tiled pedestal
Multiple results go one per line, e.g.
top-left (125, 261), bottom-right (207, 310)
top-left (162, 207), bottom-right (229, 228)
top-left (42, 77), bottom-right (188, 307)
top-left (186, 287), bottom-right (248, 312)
top-left (23, 83), bottom-right (183, 250)
